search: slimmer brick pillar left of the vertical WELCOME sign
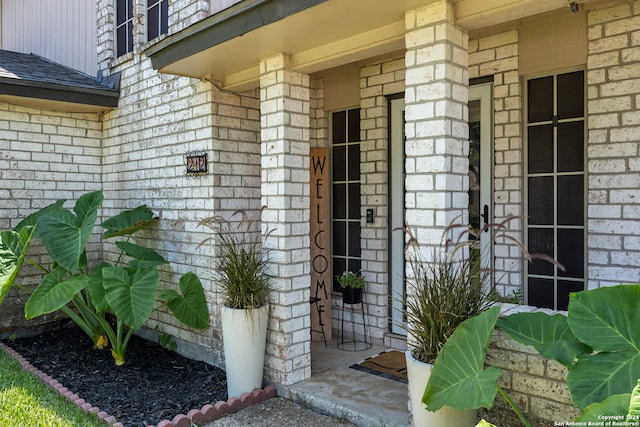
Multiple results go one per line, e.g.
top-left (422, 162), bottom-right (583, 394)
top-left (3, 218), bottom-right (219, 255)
top-left (260, 54), bottom-right (311, 384)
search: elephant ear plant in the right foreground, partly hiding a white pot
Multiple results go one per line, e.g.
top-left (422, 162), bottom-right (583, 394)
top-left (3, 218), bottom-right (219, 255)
top-left (423, 285), bottom-right (640, 426)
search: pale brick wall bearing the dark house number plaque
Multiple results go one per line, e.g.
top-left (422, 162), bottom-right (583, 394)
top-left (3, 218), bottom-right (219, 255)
top-left (98, 0), bottom-right (261, 366)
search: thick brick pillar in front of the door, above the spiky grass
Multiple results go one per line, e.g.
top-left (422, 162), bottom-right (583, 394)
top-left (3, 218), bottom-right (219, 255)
top-left (405, 0), bottom-right (469, 252)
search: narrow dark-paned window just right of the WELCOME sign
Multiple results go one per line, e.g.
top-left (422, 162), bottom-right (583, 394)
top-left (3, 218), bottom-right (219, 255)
top-left (331, 108), bottom-right (362, 291)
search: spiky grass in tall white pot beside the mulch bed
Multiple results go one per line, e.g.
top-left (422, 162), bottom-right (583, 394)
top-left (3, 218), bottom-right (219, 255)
top-left (200, 211), bottom-right (270, 398)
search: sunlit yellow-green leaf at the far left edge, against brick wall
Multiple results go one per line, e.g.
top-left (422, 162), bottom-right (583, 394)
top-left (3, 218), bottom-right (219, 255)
top-left (0, 226), bottom-right (35, 304)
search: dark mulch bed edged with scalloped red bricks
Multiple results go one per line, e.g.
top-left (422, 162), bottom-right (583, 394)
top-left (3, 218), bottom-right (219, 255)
top-left (3, 326), bottom-right (227, 426)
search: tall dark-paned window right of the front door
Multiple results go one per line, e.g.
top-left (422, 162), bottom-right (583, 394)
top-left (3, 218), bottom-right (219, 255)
top-left (526, 71), bottom-right (586, 310)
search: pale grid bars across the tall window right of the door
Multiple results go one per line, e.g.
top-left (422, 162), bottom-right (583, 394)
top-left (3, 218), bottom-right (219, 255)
top-left (526, 72), bottom-right (586, 310)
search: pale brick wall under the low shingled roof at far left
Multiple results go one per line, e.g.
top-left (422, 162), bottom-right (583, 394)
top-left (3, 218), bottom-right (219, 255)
top-left (0, 103), bottom-right (102, 331)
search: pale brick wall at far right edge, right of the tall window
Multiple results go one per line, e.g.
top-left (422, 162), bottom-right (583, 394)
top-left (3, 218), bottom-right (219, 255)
top-left (587, 1), bottom-right (640, 289)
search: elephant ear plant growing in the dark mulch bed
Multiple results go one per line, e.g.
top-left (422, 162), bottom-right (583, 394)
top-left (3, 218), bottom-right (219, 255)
top-left (0, 191), bottom-right (209, 365)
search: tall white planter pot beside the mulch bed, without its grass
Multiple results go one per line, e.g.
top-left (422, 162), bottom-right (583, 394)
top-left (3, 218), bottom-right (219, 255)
top-left (220, 305), bottom-right (269, 398)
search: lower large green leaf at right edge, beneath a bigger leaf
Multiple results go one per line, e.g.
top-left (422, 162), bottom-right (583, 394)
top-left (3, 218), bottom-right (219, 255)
top-left (567, 351), bottom-right (640, 409)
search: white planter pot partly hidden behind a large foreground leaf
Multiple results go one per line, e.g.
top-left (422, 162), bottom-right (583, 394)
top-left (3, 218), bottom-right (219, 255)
top-left (405, 350), bottom-right (477, 427)
